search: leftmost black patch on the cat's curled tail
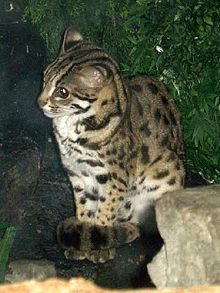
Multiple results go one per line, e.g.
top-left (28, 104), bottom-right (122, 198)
top-left (58, 225), bottom-right (81, 250)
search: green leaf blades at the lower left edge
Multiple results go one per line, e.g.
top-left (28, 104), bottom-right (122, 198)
top-left (0, 222), bottom-right (15, 283)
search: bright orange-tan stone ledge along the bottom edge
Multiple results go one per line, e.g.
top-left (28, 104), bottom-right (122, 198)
top-left (0, 279), bottom-right (220, 293)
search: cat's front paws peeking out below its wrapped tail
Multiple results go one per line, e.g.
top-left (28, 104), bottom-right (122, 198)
top-left (64, 248), bottom-right (115, 263)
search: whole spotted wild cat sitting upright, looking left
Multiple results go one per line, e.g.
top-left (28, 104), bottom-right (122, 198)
top-left (38, 28), bottom-right (185, 262)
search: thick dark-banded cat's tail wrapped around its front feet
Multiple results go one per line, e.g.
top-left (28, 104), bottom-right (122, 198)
top-left (57, 217), bottom-right (140, 250)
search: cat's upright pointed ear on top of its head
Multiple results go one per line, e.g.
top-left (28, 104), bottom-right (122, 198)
top-left (60, 26), bottom-right (83, 55)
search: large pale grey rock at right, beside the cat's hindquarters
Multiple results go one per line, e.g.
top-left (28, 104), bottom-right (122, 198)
top-left (148, 185), bottom-right (220, 288)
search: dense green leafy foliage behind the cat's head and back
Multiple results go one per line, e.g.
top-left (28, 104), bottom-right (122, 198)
top-left (24, 0), bottom-right (220, 182)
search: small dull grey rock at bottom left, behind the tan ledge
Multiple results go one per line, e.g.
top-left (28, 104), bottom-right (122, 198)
top-left (5, 259), bottom-right (56, 283)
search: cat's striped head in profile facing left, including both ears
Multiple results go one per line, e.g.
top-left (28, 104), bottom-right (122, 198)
top-left (38, 27), bottom-right (127, 122)
